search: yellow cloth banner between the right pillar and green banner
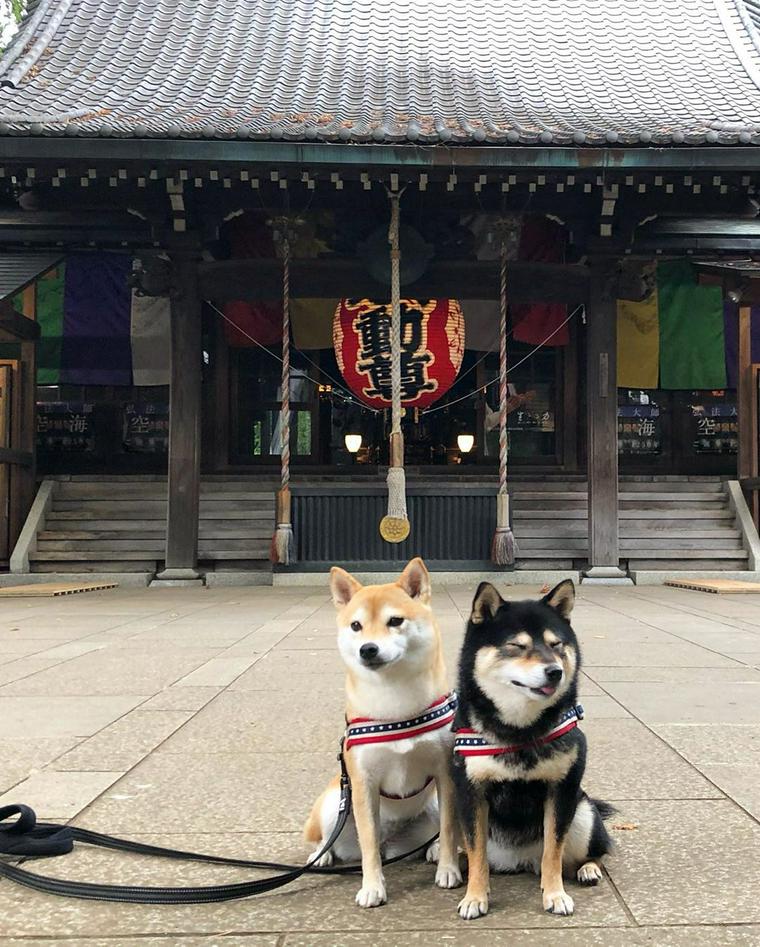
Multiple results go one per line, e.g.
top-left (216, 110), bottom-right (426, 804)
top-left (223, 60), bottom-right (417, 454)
top-left (617, 291), bottom-right (660, 388)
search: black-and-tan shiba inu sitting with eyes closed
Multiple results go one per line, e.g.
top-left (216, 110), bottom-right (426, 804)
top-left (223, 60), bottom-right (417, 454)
top-left (452, 580), bottom-right (614, 919)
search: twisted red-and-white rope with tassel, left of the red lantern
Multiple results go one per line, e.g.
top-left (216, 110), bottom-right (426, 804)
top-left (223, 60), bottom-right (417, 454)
top-left (270, 220), bottom-right (295, 566)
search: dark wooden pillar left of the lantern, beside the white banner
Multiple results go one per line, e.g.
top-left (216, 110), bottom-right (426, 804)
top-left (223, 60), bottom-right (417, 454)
top-left (156, 255), bottom-right (203, 582)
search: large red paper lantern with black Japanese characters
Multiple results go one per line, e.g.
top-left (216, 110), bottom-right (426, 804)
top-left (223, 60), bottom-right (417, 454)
top-left (333, 299), bottom-right (464, 408)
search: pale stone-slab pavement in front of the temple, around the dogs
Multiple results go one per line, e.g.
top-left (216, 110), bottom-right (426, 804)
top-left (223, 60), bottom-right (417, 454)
top-left (0, 580), bottom-right (760, 947)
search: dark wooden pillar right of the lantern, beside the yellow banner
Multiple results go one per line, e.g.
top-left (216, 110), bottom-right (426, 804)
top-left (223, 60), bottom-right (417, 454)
top-left (586, 259), bottom-right (630, 582)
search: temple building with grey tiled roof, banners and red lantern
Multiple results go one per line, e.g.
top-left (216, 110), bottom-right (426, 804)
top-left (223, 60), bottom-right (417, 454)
top-left (0, 0), bottom-right (760, 584)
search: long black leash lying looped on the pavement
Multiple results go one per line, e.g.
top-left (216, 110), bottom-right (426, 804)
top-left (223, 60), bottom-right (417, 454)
top-left (0, 745), bottom-right (438, 904)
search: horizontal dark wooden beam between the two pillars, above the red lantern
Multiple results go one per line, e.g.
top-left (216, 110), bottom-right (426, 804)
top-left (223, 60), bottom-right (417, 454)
top-left (198, 259), bottom-right (588, 304)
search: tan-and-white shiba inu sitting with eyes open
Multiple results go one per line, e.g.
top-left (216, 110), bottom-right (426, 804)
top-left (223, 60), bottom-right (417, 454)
top-left (304, 559), bottom-right (462, 907)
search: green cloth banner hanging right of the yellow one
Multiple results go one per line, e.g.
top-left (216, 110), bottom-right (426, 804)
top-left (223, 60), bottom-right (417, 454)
top-left (657, 260), bottom-right (726, 389)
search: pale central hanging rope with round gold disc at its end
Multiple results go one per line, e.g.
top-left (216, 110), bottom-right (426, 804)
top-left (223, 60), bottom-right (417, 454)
top-left (380, 191), bottom-right (409, 543)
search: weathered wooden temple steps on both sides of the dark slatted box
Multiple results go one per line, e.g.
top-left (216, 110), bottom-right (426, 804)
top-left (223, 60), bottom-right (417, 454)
top-left (19, 476), bottom-right (749, 573)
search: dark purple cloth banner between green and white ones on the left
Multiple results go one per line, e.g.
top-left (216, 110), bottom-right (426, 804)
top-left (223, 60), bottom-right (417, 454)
top-left (61, 253), bottom-right (132, 385)
